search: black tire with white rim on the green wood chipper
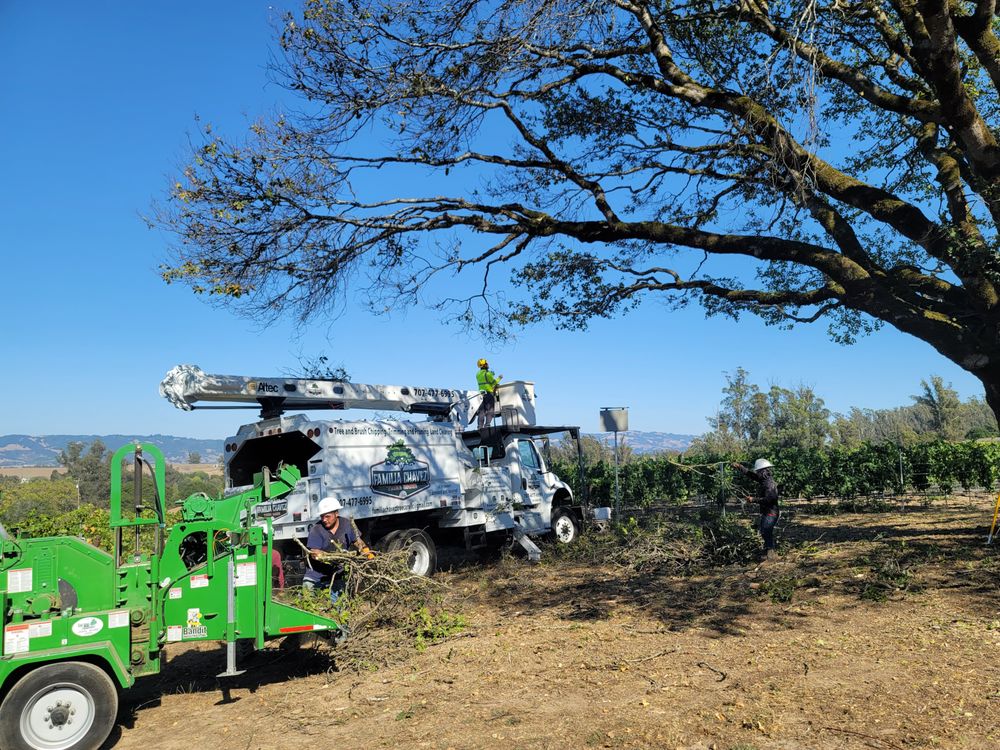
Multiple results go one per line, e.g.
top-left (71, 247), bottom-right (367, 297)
top-left (0, 661), bottom-right (118, 750)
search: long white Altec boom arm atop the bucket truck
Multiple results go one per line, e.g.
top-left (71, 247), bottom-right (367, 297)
top-left (160, 365), bottom-right (478, 421)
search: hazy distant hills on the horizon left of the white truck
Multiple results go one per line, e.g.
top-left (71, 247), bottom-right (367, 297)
top-left (0, 435), bottom-right (222, 467)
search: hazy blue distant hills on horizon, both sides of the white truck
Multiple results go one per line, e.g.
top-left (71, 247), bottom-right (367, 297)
top-left (0, 430), bottom-right (696, 468)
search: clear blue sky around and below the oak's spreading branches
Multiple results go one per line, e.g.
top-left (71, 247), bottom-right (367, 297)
top-left (0, 0), bottom-right (982, 439)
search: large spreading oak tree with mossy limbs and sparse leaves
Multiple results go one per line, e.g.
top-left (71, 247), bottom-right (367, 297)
top-left (158, 0), bottom-right (1000, 412)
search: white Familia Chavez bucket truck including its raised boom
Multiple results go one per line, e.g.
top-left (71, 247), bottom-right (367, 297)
top-left (160, 365), bottom-right (585, 575)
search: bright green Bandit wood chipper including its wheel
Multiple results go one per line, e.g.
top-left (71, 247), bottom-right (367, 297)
top-left (0, 444), bottom-right (343, 750)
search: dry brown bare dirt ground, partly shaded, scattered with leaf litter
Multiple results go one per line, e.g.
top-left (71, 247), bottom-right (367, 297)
top-left (108, 498), bottom-right (1000, 750)
